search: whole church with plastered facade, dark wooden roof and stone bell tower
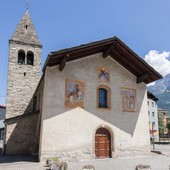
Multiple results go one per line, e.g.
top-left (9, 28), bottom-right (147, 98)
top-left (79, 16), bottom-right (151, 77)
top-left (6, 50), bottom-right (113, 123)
top-left (5, 9), bottom-right (162, 160)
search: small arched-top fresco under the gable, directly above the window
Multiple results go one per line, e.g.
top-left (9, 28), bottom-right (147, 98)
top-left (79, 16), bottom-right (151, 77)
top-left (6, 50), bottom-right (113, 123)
top-left (98, 67), bottom-right (110, 83)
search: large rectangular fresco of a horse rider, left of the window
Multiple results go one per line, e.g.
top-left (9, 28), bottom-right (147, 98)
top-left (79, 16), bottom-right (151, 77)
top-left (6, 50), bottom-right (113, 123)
top-left (65, 79), bottom-right (85, 107)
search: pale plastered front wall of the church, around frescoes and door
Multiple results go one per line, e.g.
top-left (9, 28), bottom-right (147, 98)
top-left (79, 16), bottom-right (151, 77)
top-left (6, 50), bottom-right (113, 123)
top-left (40, 53), bottom-right (149, 161)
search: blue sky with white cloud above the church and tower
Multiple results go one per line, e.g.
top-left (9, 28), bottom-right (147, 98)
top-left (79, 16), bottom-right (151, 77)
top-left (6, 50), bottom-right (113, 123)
top-left (0, 0), bottom-right (170, 104)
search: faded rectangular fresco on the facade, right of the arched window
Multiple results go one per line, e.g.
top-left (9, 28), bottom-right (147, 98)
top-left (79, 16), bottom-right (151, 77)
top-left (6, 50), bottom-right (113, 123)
top-left (121, 88), bottom-right (136, 112)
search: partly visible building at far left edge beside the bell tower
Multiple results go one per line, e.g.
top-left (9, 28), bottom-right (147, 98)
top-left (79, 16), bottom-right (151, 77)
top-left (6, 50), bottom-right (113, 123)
top-left (0, 105), bottom-right (6, 148)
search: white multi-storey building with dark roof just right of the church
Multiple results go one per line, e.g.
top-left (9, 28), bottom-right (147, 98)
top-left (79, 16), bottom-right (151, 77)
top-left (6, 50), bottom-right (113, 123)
top-left (147, 92), bottom-right (159, 141)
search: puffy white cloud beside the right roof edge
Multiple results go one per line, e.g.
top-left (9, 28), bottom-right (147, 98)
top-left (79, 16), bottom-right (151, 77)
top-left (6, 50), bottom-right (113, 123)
top-left (144, 50), bottom-right (170, 76)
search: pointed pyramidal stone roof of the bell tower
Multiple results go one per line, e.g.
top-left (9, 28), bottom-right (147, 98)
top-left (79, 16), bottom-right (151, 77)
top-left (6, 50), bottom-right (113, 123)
top-left (12, 10), bottom-right (41, 45)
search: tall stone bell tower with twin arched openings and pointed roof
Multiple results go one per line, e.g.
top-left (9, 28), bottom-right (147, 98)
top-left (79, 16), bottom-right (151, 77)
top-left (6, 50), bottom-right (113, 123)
top-left (6, 10), bottom-right (42, 119)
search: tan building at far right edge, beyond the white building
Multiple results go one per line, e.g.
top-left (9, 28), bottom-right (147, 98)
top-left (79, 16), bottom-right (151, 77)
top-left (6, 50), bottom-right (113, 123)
top-left (158, 108), bottom-right (169, 137)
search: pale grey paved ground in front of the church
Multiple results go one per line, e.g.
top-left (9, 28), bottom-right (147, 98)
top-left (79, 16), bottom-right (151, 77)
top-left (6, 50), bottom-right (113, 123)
top-left (0, 145), bottom-right (170, 170)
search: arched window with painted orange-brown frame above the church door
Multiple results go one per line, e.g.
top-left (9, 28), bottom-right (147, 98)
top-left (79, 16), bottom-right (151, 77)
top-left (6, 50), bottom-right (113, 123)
top-left (97, 86), bottom-right (111, 109)
